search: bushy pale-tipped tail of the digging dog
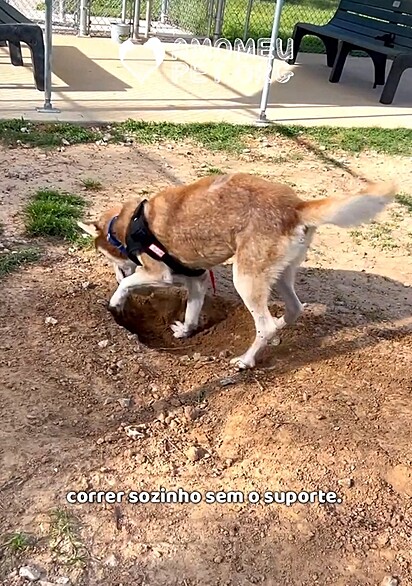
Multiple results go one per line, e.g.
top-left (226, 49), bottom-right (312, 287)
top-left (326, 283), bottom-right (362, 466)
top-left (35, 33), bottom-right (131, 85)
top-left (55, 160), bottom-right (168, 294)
top-left (299, 182), bottom-right (397, 228)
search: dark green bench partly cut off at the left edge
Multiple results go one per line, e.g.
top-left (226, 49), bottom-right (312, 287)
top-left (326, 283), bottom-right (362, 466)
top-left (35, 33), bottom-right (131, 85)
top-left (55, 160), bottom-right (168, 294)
top-left (0, 0), bottom-right (44, 91)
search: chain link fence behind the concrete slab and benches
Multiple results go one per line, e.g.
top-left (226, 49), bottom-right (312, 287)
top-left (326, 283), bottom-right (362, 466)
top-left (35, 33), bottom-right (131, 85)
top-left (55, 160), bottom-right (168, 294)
top-left (3, 0), bottom-right (339, 53)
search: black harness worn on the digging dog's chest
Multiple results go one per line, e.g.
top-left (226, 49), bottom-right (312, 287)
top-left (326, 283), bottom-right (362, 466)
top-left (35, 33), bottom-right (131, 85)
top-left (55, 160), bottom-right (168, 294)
top-left (107, 199), bottom-right (206, 277)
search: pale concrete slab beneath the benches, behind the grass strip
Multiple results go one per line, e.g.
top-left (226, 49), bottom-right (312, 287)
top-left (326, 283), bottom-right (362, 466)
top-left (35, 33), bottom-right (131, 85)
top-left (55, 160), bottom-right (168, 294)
top-left (0, 35), bottom-right (412, 128)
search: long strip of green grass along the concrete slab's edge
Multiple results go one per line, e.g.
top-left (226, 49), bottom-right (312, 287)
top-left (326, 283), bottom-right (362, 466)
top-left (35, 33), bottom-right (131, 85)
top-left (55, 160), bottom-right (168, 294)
top-left (0, 120), bottom-right (412, 157)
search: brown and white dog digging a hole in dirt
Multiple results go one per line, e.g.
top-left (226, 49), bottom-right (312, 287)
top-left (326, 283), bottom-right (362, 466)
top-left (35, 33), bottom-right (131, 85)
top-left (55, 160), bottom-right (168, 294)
top-left (79, 173), bottom-right (396, 369)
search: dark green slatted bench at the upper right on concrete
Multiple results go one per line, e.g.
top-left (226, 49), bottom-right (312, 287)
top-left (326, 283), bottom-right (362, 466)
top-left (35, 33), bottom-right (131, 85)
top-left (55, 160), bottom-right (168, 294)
top-left (289, 0), bottom-right (412, 104)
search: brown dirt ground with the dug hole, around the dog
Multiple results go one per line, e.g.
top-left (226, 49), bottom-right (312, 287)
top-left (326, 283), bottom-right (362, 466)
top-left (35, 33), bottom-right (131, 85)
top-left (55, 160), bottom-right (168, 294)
top-left (0, 122), bottom-right (412, 586)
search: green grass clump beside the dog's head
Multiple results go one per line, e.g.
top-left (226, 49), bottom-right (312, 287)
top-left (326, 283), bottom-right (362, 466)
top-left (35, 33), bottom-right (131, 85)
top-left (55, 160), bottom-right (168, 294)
top-left (25, 189), bottom-right (86, 242)
